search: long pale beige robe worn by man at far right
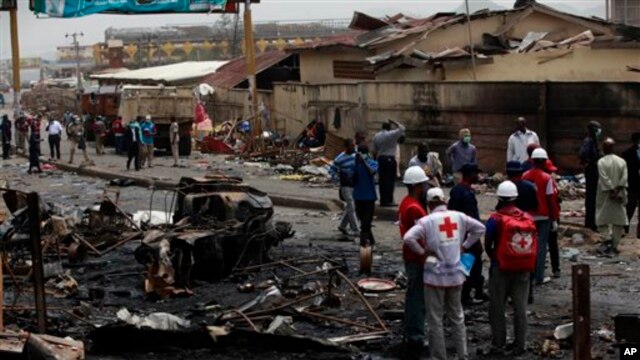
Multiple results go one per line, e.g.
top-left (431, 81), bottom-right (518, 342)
top-left (596, 154), bottom-right (629, 226)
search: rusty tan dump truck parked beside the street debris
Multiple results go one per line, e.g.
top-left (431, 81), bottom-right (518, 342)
top-left (118, 85), bottom-right (196, 156)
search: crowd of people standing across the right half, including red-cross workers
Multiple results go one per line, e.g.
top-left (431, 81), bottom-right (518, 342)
top-left (330, 118), bottom-right (640, 359)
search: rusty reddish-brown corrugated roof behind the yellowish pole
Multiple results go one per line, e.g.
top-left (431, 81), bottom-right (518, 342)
top-left (202, 51), bottom-right (292, 88)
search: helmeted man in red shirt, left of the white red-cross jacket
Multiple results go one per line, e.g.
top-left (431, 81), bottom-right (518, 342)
top-left (398, 166), bottom-right (429, 359)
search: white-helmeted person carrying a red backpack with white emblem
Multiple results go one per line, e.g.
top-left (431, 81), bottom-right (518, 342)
top-left (485, 181), bottom-right (537, 357)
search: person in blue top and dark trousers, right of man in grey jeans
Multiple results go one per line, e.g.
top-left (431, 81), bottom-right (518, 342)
top-left (353, 144), bottom-right (378, 247)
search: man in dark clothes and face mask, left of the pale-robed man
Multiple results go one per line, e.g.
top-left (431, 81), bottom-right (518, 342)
top-left (580, 121), bottom-right (602, 231)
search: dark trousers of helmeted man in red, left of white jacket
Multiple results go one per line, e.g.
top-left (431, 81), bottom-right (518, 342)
top-left (404, 262), bottom-right (425, 346)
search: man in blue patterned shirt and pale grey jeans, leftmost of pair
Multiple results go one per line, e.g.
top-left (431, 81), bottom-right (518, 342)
top-left (329, 139), bottom-right (358, 235)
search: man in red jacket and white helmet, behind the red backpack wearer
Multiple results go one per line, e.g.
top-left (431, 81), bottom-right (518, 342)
top-left (522, 148), bottom-right (558, 285)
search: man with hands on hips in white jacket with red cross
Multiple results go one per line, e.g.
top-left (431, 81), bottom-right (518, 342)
top-left (404, 188), bottom-right (485, 360)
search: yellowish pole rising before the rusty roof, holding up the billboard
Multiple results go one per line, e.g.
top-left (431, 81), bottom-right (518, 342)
top-left (244, 0), bottom-right (264, 150)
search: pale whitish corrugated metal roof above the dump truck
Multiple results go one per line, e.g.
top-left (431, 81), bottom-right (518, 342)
top-left (91, 61), bottom-right (227, 84)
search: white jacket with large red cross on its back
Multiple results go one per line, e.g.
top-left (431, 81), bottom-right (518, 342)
top-left (404, 205), bottom-right (485, 287)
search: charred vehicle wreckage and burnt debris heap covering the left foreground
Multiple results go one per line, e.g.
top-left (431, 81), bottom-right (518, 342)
top-left (0, 175), bottom-right (404, 359)
